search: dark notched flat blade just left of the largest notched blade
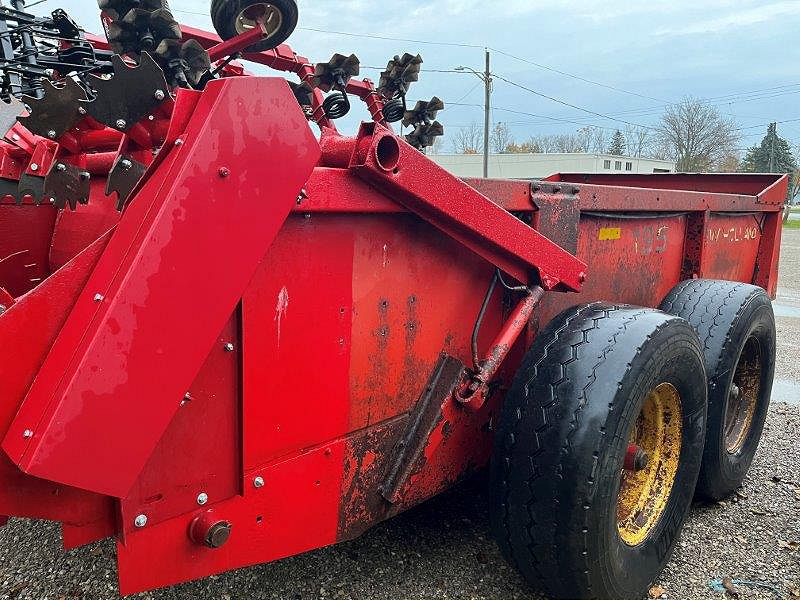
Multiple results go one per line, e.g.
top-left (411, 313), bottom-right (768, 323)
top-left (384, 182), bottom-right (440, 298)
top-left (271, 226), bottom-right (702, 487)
top-left (18, 77), bottom-right (87, 140)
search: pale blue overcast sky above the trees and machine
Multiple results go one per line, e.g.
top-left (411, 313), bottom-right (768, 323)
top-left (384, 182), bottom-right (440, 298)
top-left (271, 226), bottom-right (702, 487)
top-left (23, 0), bottom-right (800, 149)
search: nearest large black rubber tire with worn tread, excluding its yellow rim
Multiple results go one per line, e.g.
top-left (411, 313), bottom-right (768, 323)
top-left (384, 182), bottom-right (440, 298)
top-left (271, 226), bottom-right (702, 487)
top-left (490, 303), bottom-right (706, 599)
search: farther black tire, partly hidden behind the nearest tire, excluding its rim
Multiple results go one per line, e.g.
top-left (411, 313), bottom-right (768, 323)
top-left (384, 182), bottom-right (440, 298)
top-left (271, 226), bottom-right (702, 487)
top-left (661, 279), bottom-right (775, 500)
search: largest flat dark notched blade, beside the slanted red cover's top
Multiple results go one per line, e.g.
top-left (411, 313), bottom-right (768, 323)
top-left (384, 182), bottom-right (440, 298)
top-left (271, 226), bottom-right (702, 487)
top-left (83, 52), bottom-right (169, 131)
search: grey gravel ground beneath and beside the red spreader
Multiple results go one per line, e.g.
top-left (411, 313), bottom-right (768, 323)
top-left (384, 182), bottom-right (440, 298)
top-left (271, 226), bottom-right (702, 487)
top-left (0, 230), bottom-right (800, 600)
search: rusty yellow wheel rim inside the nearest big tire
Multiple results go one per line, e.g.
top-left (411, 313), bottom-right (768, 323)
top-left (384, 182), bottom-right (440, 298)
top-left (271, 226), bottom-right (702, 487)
top-left (617, 383), bottom-right (683, 546)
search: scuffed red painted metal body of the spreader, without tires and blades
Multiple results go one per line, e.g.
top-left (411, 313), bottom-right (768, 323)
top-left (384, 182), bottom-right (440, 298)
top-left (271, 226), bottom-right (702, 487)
top-left (0, 21), bottom-right (787, 593)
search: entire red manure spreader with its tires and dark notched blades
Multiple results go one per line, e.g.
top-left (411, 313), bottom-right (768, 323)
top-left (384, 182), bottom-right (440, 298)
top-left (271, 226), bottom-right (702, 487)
top-left (0, 0), bottom-right (787, 598)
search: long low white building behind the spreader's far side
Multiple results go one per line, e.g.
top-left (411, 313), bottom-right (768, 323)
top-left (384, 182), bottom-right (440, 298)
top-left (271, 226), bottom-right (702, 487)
top-left (428, 153), bottom-right (675, 179)
